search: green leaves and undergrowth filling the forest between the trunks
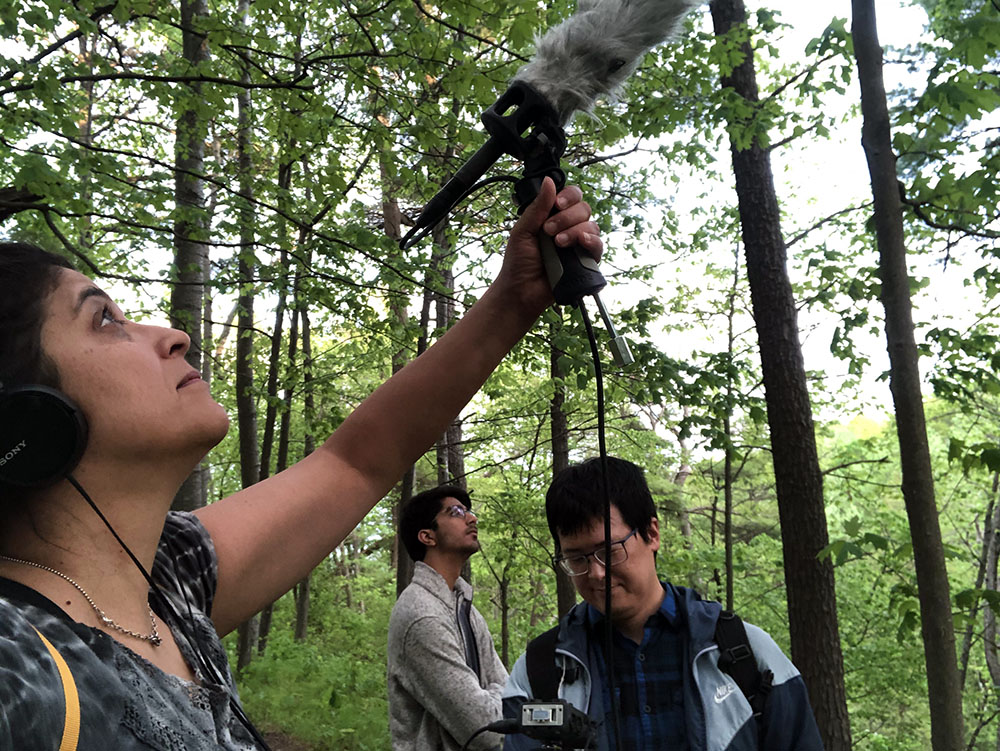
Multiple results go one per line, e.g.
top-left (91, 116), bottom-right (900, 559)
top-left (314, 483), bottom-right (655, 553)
top-left (0, 0), bottom-right (1000, 751)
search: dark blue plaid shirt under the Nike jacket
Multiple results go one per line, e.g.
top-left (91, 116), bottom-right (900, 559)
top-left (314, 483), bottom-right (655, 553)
top-left (587, 588), bottom-right (688, 751)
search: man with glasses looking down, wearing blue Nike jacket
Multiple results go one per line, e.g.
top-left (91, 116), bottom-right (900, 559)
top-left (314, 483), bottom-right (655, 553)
top-left (503, 458), bottom-right (822, 751)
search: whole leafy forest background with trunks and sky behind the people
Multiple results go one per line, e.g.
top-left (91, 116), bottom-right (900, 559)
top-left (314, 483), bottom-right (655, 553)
top-left (0, 0), bottom-right (1000, 751)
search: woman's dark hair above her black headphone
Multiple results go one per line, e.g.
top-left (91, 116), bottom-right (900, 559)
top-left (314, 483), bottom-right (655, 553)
top-left (0, 242), bottom-right (73, 388)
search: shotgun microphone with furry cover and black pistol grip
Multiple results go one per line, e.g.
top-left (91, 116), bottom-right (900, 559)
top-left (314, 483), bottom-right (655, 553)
top-left (400, 0), bottom-right (698, 366)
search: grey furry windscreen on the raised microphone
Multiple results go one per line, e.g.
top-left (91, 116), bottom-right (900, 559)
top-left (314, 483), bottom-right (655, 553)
top-left (514, 0), bottom-right (699, 125)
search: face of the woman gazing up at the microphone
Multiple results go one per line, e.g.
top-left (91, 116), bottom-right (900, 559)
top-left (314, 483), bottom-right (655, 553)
top-left (42, 269), bottom-right (229, 462)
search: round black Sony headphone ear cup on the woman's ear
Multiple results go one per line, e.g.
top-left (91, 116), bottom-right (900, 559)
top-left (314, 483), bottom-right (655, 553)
top-left (0, 386), bottom-right (87, 488)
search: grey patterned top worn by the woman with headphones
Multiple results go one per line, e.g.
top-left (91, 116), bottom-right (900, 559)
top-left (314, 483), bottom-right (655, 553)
top-left (0, 512), bottom-right (256, 751)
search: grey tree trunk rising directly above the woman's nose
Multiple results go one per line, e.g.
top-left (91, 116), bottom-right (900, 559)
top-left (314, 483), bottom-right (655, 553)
top-left (170, 0), bottom-right (209, 511)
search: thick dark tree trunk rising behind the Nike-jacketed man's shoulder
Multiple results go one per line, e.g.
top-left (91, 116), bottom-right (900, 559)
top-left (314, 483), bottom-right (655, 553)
top-left (711, 0), bottom-right (851, 751)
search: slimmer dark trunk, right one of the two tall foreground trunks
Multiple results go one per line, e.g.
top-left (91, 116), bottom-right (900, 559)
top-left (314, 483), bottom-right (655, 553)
top-left (851, 0), bottom-right (964, 751)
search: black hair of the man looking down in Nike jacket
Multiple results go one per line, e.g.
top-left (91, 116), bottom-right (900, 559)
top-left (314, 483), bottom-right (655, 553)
top-left (545, 456), bottom-right (656, 551)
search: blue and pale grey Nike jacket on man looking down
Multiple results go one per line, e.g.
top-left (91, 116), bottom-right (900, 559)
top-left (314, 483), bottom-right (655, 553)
top-left (503, 584), bottom-right (823, 751)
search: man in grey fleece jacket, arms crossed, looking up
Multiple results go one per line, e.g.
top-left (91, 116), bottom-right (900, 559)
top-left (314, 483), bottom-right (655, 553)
top-left (387, 485), bottom-right (507, 751)
